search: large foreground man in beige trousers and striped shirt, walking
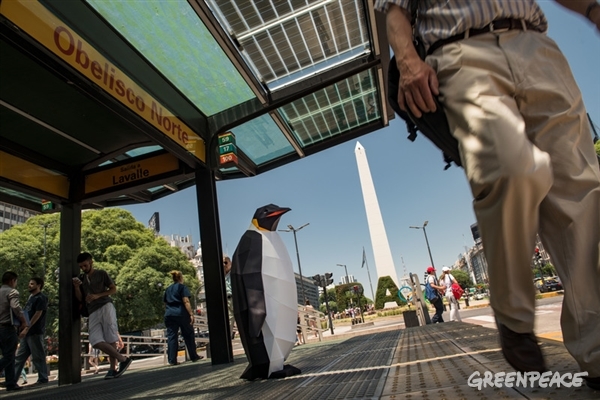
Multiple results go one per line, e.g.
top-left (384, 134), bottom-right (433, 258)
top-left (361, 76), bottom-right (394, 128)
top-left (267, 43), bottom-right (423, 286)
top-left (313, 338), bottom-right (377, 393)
top-left (376, 0), bottom-right (600, 389)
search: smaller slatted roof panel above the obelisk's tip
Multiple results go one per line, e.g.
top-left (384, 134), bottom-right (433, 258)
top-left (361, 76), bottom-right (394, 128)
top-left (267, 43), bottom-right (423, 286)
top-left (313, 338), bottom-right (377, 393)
top-left (278, 68), bottom-right (381, 147)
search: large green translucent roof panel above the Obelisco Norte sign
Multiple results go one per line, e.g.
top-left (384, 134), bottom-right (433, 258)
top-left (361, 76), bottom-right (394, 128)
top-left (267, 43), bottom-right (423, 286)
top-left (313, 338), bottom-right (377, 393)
top-left (87, 0), bottom-right (254, 115)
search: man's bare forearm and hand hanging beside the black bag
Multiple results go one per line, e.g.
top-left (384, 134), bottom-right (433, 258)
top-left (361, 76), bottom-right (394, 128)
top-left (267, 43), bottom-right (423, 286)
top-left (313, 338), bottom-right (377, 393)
top-left (386, 4), bottom-right (439, 118)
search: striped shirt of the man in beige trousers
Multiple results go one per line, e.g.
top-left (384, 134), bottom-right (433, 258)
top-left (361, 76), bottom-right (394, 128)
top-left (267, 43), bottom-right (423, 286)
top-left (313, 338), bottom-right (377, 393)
top-left (375, 0), bottom-right (548, 48)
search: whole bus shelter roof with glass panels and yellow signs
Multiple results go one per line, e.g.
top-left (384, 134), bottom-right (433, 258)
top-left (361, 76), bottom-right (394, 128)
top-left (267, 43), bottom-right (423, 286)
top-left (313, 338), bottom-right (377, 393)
top-left (0, 0), bottom-right (393, 211)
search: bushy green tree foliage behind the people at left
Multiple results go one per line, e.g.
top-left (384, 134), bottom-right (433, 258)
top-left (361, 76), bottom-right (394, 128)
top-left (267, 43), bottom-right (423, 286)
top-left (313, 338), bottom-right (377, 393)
top-left (0, 208), bottom-right (200, 337)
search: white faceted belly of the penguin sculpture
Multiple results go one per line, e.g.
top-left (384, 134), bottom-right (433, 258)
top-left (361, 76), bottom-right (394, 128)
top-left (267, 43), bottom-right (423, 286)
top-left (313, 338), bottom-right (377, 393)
top-left (261, 232), bottom-right (298, 375)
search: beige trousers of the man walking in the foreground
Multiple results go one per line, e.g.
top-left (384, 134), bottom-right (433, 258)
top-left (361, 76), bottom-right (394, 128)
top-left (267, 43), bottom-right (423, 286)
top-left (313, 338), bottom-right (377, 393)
top-left (427, 30), bottom-right (600, 376)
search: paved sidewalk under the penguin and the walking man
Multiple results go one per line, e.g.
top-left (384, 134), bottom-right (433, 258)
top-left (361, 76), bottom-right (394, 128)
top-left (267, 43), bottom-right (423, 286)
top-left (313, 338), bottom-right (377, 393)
top-left (0, 324), bottom-right (600, 400)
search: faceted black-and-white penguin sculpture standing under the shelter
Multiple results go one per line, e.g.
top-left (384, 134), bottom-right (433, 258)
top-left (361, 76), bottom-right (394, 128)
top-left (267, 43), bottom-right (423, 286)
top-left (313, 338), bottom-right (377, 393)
top-left (231, 204), bottom-right (300, 380)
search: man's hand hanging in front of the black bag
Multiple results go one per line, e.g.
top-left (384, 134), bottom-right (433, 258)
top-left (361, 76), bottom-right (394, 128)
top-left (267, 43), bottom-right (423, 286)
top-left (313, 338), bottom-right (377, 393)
top-left (396, 56), bottom-right (439, 118)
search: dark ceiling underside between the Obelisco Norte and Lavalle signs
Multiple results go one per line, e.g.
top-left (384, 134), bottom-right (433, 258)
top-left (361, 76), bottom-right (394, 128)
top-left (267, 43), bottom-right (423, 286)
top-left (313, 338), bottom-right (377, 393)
top-left (0, 41), bottom-right (155, 165)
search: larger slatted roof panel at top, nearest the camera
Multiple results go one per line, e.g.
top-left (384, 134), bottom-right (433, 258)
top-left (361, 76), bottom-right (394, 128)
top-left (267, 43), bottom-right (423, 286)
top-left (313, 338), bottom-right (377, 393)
top-left (207, 0), bottom-right (371, 90)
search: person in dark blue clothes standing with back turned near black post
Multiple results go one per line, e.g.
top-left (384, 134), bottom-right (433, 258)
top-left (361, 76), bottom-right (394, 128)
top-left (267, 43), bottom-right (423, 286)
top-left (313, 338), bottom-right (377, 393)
top-left (163, 271), bottom-right (204, 365)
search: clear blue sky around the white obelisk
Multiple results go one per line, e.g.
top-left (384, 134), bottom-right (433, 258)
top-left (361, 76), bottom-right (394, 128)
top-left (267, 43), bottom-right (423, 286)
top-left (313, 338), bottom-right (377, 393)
top-left (125, 1), bottom-right (600, 297)
